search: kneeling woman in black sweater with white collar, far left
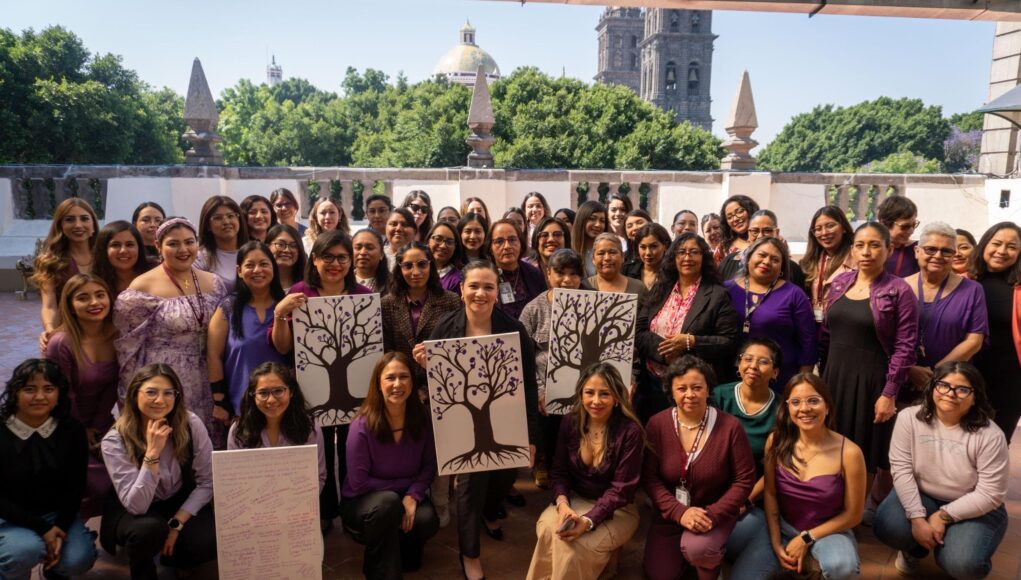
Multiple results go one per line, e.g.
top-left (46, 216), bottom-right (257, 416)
top-left (0, 358), bottom-right (96, 580)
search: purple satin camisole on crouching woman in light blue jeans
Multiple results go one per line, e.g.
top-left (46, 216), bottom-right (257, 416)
top-left (776, 438), bottom-right (847, 530)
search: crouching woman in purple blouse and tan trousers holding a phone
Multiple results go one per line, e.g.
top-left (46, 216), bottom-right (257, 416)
top-left (528, 363), bottom-right (644, 578)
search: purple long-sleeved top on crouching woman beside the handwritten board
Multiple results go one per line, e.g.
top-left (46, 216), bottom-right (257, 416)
top-left (340, 414), bottom-right (436, 501)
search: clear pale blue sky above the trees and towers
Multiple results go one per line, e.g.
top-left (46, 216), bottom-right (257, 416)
top-left (0, 0), bottom-right (993, 144)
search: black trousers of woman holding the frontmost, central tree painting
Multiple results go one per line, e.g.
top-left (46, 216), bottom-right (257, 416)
top-left (454, 470), bottom-right (518, 558)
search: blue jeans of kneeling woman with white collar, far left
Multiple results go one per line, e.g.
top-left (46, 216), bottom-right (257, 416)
top-left (0, 513), bottom-right (96, 580)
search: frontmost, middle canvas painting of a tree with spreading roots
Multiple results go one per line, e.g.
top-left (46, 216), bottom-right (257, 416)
top-left (425, 333), bottom-right (528, 475)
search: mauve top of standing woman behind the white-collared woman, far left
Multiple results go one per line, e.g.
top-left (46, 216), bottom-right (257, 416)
top-left (46, 332), bottom-right (118, 434)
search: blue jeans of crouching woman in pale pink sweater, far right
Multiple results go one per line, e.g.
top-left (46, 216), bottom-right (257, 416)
top-left (872, 490), bottom-right (1008, 579)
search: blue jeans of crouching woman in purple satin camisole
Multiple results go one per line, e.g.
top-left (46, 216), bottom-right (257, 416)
top-left (728, 514), bottom-right (861, 580)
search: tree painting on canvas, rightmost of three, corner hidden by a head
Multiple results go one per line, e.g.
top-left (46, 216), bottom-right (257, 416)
top-left (546, 288), bottom-right (638, 415)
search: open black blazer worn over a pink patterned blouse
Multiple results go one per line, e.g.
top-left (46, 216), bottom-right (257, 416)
top-left (635, 280), bottom-right (741, 380)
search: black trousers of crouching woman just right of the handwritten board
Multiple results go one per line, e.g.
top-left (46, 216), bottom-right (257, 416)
top-left (340, 491), bottom-right (440, 580)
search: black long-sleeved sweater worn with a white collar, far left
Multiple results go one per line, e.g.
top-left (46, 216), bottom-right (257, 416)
top-left (0, 418), bottom-right (89, 535)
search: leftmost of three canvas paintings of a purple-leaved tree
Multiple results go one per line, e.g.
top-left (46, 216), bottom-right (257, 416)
top-left (294, 294), bottom-right (383, 427)
